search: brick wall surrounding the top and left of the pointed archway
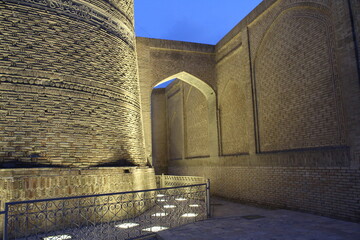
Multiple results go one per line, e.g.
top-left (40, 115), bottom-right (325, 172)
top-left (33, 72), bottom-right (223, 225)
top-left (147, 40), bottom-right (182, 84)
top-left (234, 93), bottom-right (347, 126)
top-left (136, 37), bottom-right (216, 158)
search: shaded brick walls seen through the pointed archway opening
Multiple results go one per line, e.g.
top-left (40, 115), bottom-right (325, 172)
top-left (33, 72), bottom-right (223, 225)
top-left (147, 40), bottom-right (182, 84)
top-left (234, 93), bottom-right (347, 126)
top-left (152, 80), bottom-right (210, 161)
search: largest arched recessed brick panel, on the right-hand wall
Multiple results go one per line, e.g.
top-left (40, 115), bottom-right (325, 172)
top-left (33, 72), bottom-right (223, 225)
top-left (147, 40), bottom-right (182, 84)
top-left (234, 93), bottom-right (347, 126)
top-left (255, 7), bottom-right (343, 151)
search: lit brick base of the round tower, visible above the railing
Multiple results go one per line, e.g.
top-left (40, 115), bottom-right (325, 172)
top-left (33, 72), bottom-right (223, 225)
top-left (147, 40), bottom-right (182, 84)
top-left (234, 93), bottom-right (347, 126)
top-left (0, 167), bottom-right (156, 239)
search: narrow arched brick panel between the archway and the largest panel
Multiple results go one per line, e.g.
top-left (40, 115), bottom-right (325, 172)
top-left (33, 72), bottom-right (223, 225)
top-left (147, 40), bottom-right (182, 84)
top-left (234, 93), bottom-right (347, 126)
top-left (216, 48), bottom-right (250, 155)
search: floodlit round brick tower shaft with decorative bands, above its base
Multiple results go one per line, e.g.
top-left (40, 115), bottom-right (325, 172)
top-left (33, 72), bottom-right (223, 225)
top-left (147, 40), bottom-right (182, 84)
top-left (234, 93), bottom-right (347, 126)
top-left (0, 0), bottom-right (146, 168)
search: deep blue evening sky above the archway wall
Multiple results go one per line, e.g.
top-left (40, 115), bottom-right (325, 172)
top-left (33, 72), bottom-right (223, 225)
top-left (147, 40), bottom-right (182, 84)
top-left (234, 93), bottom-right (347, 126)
top-left (134, 0), bottom-right (261, 44)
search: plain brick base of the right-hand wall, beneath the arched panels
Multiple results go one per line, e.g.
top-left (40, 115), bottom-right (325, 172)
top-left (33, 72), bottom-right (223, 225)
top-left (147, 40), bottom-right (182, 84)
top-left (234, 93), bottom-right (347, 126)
top-left (170, 167), bottom-right (360, 221)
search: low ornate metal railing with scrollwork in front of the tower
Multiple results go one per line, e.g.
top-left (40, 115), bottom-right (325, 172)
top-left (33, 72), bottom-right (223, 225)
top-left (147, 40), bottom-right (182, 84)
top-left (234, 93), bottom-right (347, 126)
top-left (3, 176), bottom-right (210, 240)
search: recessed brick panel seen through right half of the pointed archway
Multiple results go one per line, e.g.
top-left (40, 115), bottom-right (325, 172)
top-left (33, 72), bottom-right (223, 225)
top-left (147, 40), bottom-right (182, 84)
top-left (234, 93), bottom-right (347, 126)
top-left (182, 82), bottom-right (209, 158)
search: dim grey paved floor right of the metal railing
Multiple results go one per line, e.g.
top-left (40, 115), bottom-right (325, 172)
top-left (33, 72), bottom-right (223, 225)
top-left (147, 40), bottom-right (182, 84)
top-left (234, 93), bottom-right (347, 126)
top-left (158, 198), bottom-right (360, 240)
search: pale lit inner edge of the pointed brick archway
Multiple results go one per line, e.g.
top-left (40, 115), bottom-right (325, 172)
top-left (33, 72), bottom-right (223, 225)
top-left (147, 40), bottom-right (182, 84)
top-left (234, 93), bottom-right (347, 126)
top-left (152, 72), bottom-right (219, 172)
